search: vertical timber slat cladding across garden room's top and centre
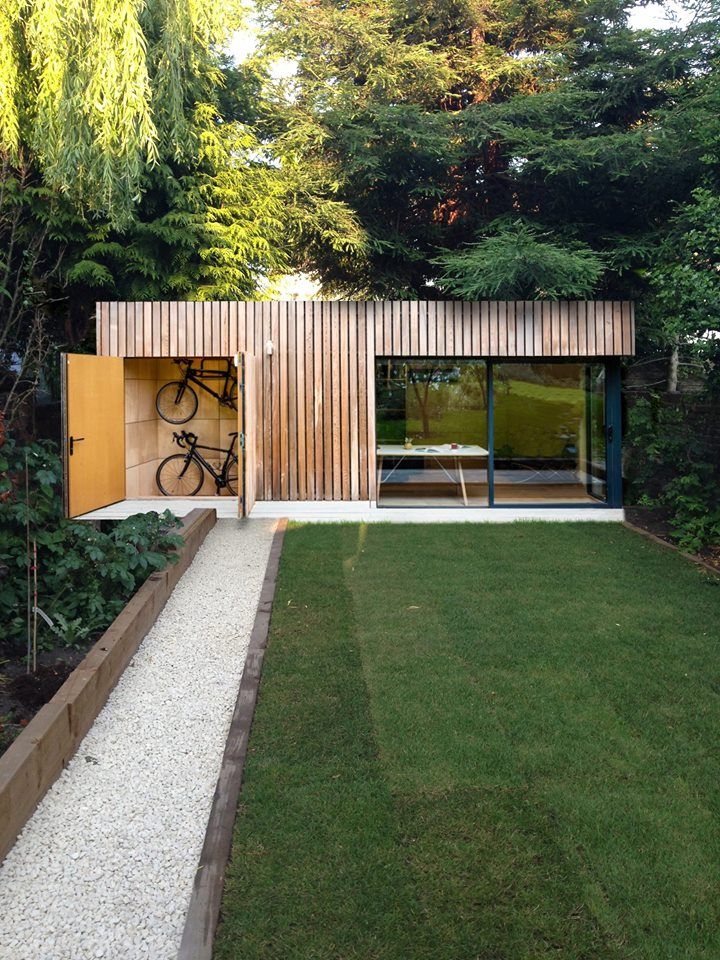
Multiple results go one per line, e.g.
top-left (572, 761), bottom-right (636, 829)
top-left (96, 300), bottom-right (635, 500)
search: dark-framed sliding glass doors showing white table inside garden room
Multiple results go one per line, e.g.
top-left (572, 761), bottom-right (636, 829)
top-left (375, 357), bottom-right (621, 507)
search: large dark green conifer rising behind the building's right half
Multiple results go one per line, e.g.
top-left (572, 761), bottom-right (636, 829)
top-left (256, 0), bottom-right (718, 297)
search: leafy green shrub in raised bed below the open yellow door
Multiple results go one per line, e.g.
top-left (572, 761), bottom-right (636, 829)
top-left (0, 440), bottom-right (182, 650)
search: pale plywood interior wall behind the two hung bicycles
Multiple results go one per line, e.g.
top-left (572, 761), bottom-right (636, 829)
top-left (125, 358), bottom-right (237, 499)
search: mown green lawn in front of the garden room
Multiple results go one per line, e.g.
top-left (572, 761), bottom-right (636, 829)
top-left (215, 523), bottom-right (720, 960)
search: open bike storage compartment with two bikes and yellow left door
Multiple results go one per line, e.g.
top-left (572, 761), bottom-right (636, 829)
top-left (61, 354), bottom-right (255, 517)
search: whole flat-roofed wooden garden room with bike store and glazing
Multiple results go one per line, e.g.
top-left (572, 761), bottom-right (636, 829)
top-left (63, 301), bottom-right (634, 516)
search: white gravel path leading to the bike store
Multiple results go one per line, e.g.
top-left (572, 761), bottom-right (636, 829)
top-left (0, 520), bottom-right (275, 960)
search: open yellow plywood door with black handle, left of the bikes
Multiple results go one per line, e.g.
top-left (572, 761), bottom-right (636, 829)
top-left (62, 353), bottom-right (125, 517)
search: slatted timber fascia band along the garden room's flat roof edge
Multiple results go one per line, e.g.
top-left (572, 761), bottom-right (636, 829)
top-left (96, 300), bottom-right (635, 359)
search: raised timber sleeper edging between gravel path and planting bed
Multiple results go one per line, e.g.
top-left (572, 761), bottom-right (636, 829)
top-left (0, 509), bottom-right (217, 862)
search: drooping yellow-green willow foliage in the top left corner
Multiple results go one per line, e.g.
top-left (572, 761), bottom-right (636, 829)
top-left (0, 0), bottom-right (242, 223)
